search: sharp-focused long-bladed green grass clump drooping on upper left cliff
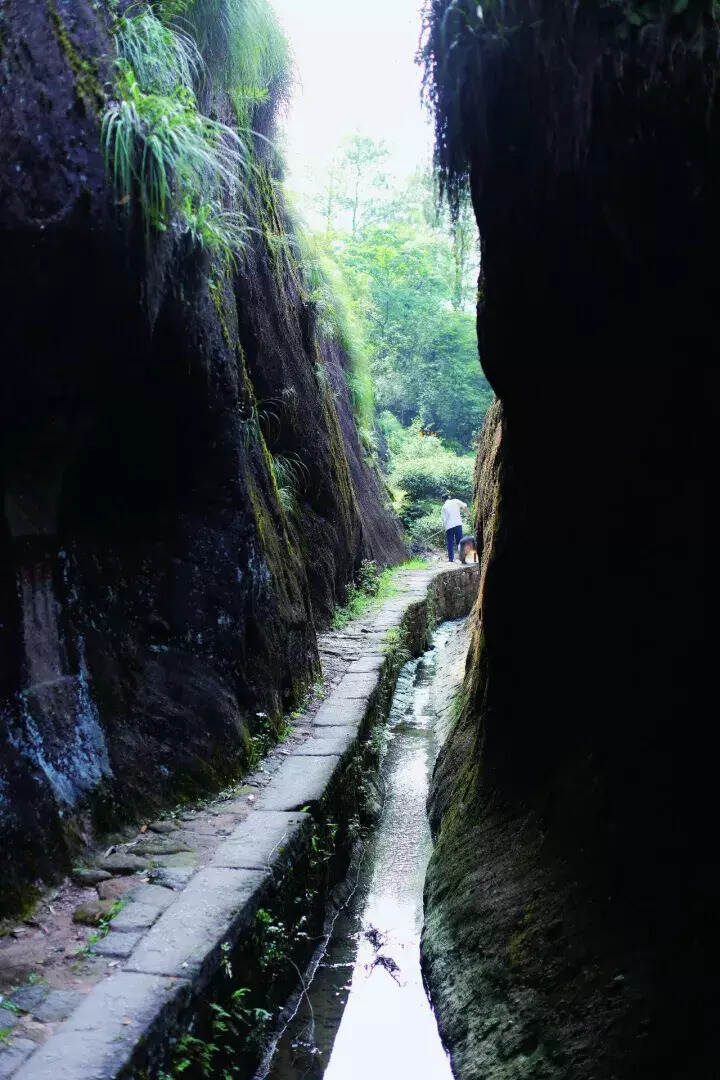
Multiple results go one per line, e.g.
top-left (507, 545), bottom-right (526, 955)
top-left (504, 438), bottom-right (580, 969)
top-left (101, 9), bottom-right (252, 264)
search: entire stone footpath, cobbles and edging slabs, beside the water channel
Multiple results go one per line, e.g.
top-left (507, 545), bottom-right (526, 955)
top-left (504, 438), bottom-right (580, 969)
top-left (0, 563), bottom-right (479, 1080)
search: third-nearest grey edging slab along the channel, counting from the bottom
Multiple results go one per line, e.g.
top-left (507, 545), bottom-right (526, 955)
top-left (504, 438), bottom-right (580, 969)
top-left (210, 809), bottom-right (311, 870)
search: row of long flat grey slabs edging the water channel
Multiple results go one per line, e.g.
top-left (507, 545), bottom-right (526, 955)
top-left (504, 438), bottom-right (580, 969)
top-left (9, 568), bottom-right (479, 1080)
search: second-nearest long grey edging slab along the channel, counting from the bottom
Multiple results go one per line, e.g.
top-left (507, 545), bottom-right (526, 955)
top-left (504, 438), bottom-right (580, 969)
top-left (125, 866), bottom-right (270, 989)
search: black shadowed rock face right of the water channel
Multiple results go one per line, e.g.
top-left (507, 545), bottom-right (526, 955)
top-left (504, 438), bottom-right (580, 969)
top-left (423, 2), bottom-right (720, 1080)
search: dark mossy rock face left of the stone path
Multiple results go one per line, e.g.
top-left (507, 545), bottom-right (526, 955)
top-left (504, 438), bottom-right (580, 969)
top-left (0, 0), bottom-right (403, 908)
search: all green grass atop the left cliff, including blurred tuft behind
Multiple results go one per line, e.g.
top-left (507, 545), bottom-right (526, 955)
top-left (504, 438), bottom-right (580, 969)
top-left (101, 0), bottom-right (289, 266)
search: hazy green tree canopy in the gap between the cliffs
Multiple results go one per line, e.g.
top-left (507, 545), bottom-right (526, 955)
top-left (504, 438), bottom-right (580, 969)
top-left (306, 135), bottom-right (492, 450)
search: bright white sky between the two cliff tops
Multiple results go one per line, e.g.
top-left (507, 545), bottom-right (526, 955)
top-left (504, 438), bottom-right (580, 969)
top-left (271, 0), bottom-right (431, 196)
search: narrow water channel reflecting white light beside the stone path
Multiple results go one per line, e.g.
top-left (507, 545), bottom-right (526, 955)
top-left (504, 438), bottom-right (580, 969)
top-left (260, 620), bottom-right (465, 1080)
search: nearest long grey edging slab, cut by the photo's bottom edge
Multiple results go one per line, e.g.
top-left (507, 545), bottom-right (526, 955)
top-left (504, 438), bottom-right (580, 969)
top-left (11, 971), bottom-right (190, 1080)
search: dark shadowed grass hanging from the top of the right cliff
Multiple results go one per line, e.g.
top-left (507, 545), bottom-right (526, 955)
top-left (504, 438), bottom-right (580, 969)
top-left (420, 0), bottom-right (720, 216)
